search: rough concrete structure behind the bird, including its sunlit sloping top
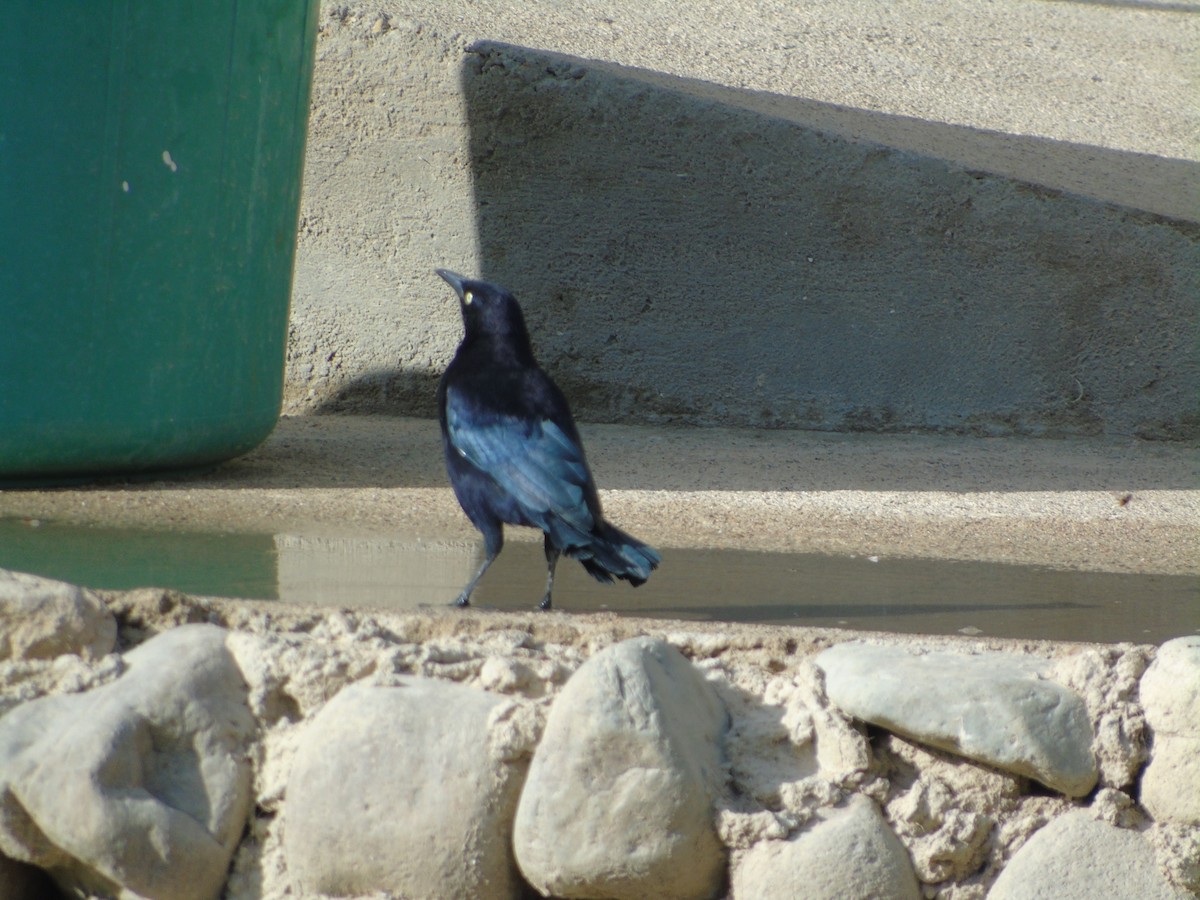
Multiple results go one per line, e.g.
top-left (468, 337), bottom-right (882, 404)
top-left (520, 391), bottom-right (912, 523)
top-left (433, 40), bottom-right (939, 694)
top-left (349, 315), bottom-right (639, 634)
top-left (287, 1), bottom-right (1200, 438)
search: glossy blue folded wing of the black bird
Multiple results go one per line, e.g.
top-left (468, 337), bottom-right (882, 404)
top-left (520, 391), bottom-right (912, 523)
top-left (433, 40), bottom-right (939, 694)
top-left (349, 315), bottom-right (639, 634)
top-left (446, 389), bottom-right (595, 534)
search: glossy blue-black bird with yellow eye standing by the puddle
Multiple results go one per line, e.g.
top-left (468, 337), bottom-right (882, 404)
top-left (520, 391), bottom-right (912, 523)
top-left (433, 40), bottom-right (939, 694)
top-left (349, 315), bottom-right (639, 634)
top-left (437, 269), bottom-right (661, 610)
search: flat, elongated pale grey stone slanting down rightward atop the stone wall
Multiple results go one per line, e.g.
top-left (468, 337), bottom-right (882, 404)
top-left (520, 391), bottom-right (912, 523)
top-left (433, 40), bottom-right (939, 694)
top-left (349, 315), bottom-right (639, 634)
top-left (816, 643), bottom-right (1097, 797)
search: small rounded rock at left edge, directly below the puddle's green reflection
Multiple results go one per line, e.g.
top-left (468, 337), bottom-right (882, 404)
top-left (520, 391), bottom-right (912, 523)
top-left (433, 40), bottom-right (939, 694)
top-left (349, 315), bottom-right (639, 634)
top-left (0, 569), bottom-right (116, 660)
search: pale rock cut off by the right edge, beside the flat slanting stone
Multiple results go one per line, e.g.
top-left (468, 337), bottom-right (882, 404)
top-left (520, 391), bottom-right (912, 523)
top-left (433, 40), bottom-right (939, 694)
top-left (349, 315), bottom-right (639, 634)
top-left (1139, 636), bottom-right (1200, 824)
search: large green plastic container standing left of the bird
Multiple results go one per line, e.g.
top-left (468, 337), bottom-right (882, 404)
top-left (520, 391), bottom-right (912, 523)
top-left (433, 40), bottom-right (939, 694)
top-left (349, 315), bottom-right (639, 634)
top-left (0, 0), bottom-right (318, 482)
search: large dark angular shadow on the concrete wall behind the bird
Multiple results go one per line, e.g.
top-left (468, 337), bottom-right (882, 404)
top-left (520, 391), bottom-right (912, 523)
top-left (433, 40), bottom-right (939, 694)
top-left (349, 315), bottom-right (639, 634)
top-left (444, 43), bottom-right (1200, 438)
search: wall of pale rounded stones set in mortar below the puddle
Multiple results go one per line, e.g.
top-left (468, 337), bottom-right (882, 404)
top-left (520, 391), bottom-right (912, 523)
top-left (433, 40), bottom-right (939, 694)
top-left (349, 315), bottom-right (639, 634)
top-left (0, 571), bottom-right (1200, 900)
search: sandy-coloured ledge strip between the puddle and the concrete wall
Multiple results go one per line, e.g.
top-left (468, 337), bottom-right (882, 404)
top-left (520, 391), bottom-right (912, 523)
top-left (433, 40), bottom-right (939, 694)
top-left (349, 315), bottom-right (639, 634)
top-left (0, 416), bottom-right (1200, 574)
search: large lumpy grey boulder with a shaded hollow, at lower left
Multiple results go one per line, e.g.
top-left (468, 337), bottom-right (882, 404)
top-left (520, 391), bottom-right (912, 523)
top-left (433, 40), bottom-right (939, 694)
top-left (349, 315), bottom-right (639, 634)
top-left (0, 625), bottom-right (254, 900)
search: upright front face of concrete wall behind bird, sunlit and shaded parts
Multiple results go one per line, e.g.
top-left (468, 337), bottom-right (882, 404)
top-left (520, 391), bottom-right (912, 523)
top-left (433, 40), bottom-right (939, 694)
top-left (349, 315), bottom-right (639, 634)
top-left (286, 10), bottom-right (1200, 438)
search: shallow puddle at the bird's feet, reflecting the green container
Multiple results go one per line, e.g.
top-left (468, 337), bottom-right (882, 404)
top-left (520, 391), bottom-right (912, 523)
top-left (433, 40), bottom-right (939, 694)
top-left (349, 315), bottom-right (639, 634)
top-left (0, 520), bottom-right (1200, 643)
